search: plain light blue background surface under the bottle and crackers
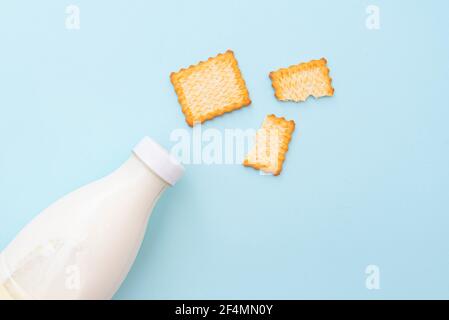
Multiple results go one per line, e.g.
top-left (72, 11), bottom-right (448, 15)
top-left (0, 0), bottom-right (449, 299)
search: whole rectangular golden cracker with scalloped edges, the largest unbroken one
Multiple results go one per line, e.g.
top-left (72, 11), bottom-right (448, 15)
top-left (170, 50), bottom-right (251, 126)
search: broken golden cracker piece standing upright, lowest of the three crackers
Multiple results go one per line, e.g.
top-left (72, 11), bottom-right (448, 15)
top-left (243, 114), bottom-right (295, 176)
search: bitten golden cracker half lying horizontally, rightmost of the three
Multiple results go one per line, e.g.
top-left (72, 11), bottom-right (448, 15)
top-left (270, 58), bottom-right (334, 102)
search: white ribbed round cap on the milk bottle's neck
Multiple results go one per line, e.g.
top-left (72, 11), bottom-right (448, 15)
top-left (133, 137), bottom-right (184, 186)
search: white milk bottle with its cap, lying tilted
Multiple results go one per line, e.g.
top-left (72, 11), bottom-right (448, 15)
top-left (0, 137), bottom-right (184, 299)
